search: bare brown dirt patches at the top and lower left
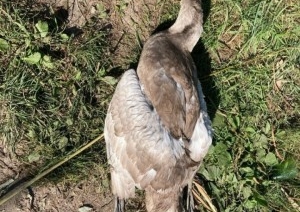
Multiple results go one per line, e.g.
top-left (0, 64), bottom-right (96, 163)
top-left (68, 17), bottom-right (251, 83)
top-left (0, 0), bottom-right (170, 212)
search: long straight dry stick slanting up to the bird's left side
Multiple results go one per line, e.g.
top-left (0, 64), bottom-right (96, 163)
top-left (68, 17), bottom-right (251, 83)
top-left (0, 133), bottom-right (104, 205)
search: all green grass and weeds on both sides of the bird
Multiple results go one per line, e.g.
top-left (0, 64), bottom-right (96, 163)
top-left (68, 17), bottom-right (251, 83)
top-left (0, 0), bottom-right (300, 211)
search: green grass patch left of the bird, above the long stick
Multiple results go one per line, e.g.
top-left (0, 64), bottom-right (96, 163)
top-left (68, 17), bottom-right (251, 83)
top-left (0, 1), bottom-right (116, 180)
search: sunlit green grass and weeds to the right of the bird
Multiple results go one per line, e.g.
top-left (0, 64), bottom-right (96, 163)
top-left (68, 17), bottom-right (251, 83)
top-left (195, 0), bottom-right (300, 211)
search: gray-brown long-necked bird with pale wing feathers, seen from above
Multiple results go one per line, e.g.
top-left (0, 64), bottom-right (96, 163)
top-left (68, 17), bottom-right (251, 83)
top-left (104, 0), bottom-right (212, 212)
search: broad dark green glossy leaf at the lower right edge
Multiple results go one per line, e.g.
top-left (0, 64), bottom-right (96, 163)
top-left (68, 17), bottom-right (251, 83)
top-left (273, 158), bottom-right (298, 180)
